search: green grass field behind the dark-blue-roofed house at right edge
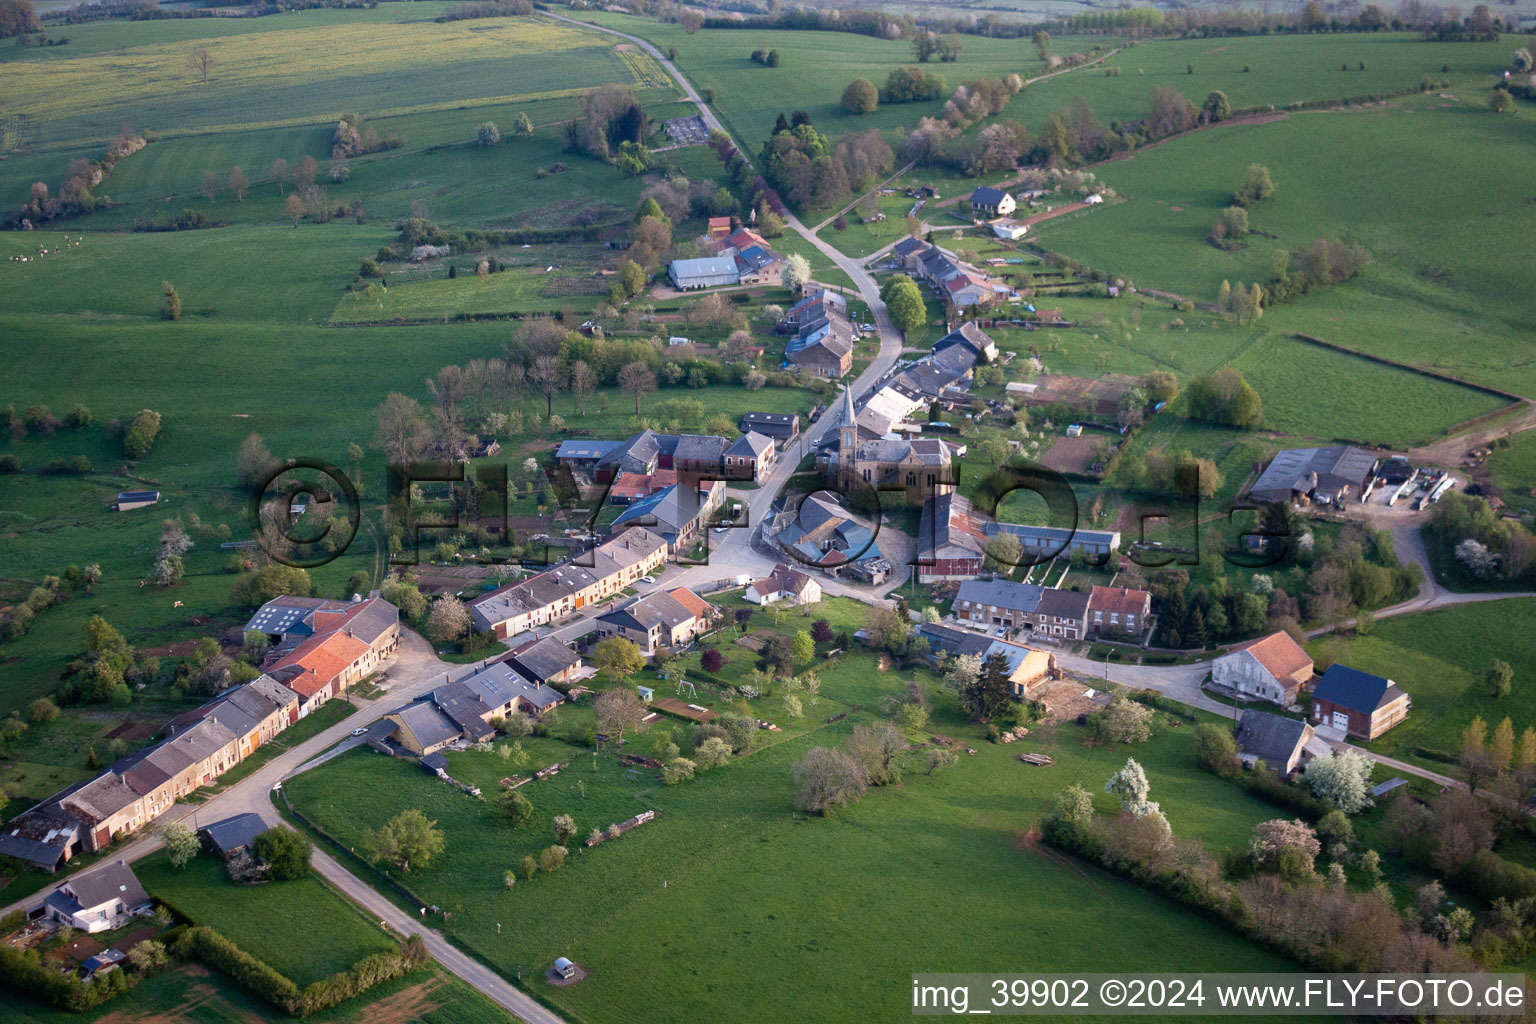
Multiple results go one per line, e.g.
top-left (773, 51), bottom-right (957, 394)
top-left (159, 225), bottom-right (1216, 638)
top-left (1312, 599), bottom-right (1536, 771)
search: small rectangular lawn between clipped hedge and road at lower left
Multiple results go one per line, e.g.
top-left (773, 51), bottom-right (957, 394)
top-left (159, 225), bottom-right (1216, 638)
top-left (134, 852), bottom-right (393, 987)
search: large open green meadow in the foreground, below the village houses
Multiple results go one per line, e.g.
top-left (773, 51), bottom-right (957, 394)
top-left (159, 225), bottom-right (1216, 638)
top-left (287, 635), bottom-right (1286, 1021)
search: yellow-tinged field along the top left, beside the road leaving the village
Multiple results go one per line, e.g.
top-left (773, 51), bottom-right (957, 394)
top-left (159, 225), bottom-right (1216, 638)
top-left (0, 3), bottom-right (660, 157)
